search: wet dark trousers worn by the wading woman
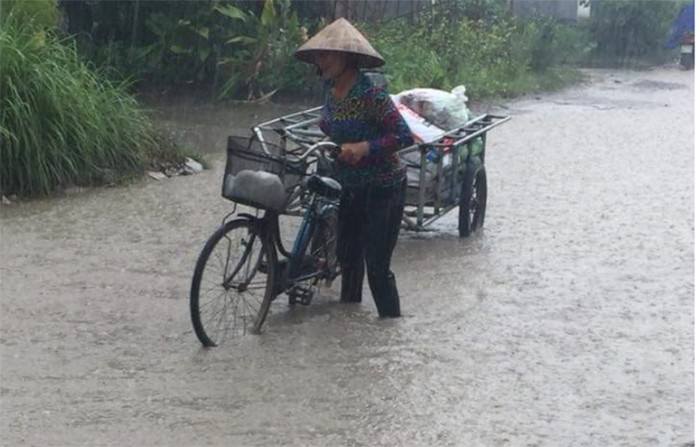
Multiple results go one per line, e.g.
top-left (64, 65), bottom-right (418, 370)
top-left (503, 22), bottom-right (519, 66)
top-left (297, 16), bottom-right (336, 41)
top-left (338, 179), bottom-right (406, 317)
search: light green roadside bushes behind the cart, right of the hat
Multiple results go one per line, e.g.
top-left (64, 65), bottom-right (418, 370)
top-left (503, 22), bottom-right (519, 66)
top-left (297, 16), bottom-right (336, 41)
top-left (366, 9), bottom-right (590, 98)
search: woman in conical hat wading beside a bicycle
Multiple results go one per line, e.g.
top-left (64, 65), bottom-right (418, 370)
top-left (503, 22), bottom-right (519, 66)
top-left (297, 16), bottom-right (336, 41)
top-left (294, 18), bottom-right (413, 317)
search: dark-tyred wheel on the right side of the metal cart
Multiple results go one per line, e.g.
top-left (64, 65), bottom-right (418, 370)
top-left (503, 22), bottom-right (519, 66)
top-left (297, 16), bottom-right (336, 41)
top-left (459, 163), bottom-right (486, 237)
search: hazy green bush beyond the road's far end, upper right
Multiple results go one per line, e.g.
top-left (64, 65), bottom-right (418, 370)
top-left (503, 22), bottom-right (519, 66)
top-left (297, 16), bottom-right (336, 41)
top-left (590, 0), bottom-right (679, 63)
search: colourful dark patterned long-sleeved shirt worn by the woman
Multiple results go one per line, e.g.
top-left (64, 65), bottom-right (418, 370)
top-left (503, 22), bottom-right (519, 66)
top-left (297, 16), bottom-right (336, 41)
top-left (319, 73), bottom-right (413, 187)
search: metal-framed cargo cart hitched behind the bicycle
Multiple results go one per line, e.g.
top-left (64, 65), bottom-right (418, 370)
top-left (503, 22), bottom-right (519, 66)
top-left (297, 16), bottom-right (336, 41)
top-left (251, 107), bottom-right (510, 237)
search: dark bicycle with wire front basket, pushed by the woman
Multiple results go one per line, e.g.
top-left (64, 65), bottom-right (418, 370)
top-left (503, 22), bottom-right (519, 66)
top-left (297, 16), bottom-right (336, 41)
top-left (190, 137), bottom-right (341, 347)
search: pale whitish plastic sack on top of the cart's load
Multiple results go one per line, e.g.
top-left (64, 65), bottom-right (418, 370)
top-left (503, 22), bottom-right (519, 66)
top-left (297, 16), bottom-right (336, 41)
top-left (395, 85), bottom-right (469, 130)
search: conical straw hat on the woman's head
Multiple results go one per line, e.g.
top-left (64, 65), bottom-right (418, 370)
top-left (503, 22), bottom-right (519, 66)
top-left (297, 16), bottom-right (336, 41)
top-left (294, 17), bottom-right (384, 68)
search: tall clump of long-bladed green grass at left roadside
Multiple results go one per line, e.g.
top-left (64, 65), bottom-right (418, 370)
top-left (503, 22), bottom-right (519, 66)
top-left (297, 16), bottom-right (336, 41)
top-left (0, 14), bottom-right (172, 196)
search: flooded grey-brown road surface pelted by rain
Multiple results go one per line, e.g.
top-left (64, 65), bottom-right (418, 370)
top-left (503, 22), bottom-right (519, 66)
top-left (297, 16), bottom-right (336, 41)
top-left (0, 68), bottom-right (694, 447)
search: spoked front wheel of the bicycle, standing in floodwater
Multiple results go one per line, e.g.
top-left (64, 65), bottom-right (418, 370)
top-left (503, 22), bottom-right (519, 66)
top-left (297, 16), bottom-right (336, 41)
top-left (190, 219), bottom-right (277, 346)
